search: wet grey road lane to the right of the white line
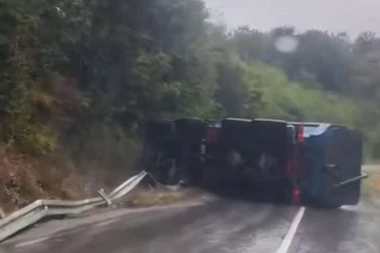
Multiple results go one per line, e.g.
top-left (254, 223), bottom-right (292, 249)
top-left (289, 202), bottom-right (380, 253)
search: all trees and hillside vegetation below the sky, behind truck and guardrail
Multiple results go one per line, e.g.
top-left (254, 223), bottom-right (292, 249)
top-left (0, 0), bottom-right (380, 209)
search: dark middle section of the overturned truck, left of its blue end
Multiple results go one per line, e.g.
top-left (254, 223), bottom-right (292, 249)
top-left (203, 119), bottom-right (295, 204)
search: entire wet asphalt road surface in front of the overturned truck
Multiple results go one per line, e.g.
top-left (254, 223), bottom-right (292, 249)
top-left (0, 197), bottom-right (380, 253)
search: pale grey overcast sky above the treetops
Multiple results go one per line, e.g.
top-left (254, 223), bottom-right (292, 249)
top-left (204, 0), bottom-right (380, 37)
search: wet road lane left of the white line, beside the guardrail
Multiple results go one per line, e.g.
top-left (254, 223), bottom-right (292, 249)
top-left (4, 201), bottom-right (298, 253)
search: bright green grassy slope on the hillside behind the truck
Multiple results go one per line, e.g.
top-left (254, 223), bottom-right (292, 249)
top-left (240, 63), bottom-right (357, 126)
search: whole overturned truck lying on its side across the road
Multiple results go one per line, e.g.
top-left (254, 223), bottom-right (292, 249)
top-left (142, 118), bottom-right (365, 208)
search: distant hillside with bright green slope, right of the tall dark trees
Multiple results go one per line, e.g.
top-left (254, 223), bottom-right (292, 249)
top-left (221, 24), bottom-right (380, 157)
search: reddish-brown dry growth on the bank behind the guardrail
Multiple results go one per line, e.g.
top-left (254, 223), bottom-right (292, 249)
top-left (0, 151), bottom-right (86, 213)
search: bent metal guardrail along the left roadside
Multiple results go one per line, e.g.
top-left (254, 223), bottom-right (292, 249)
top-left (0, 171), bottom-right (148, 242)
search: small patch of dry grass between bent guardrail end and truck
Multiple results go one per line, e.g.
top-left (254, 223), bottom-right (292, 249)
top-left (124, 187), bottom-right (201, 207)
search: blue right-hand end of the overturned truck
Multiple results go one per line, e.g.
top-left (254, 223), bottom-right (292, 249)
top-left (290, 123), bottom-right (366, 207)
